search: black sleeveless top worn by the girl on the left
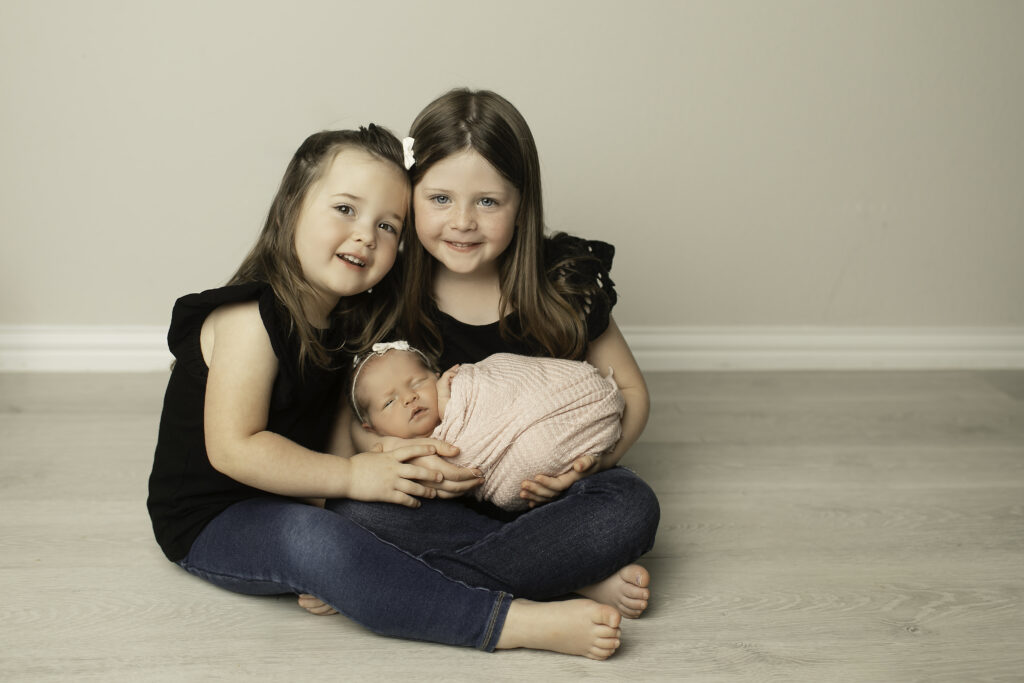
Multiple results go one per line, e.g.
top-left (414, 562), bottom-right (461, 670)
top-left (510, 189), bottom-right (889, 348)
top-left (146, 283), bottom-right (350, 562)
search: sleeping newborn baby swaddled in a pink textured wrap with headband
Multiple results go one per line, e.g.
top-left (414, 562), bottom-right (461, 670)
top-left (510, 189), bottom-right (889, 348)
top-left (352, 342), bottom-right (625, 510)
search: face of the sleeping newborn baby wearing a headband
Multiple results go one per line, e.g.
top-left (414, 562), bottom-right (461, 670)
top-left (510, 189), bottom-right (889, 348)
top-left (356, 349), bottom-right (440, 438)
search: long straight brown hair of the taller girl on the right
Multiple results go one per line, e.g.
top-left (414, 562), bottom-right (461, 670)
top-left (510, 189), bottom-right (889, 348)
top-left (402, 88), bottom-right (587, 358)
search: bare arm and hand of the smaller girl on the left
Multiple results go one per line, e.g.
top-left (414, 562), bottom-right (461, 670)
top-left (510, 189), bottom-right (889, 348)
top-left (202, 302), bottom-right (437, 507)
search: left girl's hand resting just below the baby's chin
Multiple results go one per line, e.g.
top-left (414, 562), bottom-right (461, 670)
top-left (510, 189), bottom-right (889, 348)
top-left (345, 443), bottom-right (443, 508)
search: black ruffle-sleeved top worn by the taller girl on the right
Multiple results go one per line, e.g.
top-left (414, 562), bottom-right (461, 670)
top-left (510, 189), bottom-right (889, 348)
top-left (428, 233), bottom-right (617, 370)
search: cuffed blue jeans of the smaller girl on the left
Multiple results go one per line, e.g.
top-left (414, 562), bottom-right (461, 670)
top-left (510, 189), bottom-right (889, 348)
top-left (178, 498), bottom-right (511, 651)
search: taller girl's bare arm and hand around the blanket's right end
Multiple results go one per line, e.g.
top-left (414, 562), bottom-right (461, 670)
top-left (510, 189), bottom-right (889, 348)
top-left (521, 318), bottom-right (650, 507)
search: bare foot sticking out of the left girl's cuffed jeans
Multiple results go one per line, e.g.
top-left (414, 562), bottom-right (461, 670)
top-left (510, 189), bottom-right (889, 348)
top-left (497, 600), bottom-right (622, 659)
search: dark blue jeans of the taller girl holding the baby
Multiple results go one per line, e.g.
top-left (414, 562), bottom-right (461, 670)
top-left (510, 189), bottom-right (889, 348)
top-left (327, 467), bottom-right (660, 600)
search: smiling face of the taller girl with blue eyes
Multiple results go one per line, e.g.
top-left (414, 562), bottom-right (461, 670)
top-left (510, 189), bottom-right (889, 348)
top-left (413, 150), bottom-right (519, 274)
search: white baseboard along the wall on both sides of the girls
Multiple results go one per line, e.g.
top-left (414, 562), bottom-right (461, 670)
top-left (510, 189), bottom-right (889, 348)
top-left (0, 325), bottom-right (1024, 372)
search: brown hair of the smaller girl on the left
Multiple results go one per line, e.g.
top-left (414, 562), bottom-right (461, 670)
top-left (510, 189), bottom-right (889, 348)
top-left (228, 124), bottom-right (411, 368)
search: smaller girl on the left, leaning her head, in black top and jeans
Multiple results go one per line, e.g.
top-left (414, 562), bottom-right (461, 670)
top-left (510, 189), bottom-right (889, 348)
top-left (147, 126), bottom-right (620, 658)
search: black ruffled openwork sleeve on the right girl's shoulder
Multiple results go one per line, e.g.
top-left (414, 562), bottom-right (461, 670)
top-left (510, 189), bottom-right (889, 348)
top-left (544, 232), bottom-right (618, 341)
